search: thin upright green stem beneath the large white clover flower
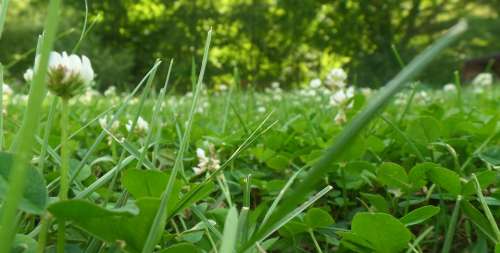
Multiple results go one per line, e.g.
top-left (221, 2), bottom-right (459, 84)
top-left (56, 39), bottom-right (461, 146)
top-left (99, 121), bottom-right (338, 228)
top-left (57, 98), bottom-right (69, 253)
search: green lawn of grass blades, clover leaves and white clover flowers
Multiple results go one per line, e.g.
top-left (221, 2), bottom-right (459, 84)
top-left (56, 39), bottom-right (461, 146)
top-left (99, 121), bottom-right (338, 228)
top-left (0, 0), bottom-right (500, 253)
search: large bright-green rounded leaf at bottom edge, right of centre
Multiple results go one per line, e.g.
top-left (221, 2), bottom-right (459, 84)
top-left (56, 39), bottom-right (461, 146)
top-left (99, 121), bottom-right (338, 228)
top-left (351, 212), bottom-right (412, 253)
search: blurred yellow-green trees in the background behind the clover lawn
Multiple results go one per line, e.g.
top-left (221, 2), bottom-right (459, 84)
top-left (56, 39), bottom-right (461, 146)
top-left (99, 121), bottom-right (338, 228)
top-left (0, 0), bottom-right (500, 91)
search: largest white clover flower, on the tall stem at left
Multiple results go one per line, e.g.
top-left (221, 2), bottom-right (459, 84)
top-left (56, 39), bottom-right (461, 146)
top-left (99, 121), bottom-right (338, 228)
top-left (43, 52), bottom-right (95, 99)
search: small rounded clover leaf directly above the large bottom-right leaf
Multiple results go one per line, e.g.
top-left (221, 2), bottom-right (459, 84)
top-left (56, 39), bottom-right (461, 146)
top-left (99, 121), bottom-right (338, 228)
top-left (377, 162), bottom-right (410, 189)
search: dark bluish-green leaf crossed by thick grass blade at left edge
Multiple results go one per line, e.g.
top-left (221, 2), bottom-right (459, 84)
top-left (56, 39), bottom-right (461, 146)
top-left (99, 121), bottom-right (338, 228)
top-left (0, 152), bottom-right (48, 214)
